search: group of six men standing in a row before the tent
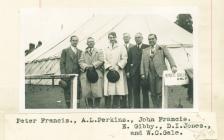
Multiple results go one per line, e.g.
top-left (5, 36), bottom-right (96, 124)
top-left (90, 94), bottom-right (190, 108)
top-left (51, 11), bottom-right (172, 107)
top-left (60, 32), bottom-right (177, 108)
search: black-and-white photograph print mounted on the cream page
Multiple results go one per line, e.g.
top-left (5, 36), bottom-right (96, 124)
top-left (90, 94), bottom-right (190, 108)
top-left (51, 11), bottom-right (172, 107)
top-left (21, 8), bottom-right (197, 110)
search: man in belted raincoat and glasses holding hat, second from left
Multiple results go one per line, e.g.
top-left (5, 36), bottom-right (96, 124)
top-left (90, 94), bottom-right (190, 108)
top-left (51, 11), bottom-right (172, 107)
top-left (79, 37), bottom-right (104, 108)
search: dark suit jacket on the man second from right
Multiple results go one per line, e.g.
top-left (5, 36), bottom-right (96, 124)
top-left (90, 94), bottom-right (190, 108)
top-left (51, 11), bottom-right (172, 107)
top-left (127, 44), bottom-right (149, 77)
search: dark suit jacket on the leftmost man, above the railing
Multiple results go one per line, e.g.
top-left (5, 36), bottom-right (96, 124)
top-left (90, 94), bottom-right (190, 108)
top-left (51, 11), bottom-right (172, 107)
top-left (60, 47), bottom-right (82, 74)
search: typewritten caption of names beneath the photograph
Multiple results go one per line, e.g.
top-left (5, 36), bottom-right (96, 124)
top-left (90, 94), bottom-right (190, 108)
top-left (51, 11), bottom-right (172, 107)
top-left (16, 116), bottom-right (211, 136)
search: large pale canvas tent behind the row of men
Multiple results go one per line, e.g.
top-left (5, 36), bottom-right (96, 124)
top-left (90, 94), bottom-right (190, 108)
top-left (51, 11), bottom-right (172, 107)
top-left (25, 15), bottom-right (193, 85)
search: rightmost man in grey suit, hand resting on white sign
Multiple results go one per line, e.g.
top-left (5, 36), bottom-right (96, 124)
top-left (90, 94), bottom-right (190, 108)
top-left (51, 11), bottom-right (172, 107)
top-left (140, 34), bottom-right (177, 108)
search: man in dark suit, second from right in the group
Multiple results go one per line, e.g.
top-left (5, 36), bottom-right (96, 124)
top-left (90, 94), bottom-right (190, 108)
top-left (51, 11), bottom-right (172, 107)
top-left (127, 33), bottom-right (149, 108)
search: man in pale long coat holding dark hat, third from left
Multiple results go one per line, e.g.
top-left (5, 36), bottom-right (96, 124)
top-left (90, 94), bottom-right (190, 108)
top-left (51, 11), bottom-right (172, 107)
top-left (104, 32), bottom-right (128, 108)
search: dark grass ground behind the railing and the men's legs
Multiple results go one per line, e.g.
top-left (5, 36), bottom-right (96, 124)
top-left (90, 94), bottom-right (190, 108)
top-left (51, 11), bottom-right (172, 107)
top-left (25, 85), bottom-right (193, 109)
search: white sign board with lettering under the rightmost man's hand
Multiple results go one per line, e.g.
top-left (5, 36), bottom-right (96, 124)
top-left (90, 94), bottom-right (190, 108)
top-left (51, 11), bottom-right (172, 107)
top-left (163, 70), bottom-right (189, 86)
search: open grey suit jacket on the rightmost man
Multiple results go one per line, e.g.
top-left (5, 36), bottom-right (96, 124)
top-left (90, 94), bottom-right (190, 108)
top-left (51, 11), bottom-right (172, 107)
top-left (140, 45), bottom-right (176, 77)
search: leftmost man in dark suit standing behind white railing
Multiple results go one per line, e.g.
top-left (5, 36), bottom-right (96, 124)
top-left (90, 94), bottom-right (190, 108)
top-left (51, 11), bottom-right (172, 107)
top-left (60, 35), bottom-right (82, 108)
